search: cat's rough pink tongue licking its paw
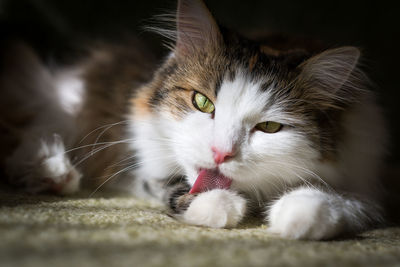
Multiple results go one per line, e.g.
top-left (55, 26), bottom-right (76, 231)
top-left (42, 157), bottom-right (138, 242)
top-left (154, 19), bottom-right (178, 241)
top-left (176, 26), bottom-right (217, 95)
top-left (189, 170), bottom-right (232, 194)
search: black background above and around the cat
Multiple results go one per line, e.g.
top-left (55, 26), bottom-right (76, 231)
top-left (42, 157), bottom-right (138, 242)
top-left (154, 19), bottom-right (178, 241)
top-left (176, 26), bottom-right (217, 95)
top-left (0, 0), bottom-right (400, 166)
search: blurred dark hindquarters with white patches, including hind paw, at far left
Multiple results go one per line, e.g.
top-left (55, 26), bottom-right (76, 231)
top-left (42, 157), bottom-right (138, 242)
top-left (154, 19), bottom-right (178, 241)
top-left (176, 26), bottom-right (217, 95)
top-left (0, 44), bottom-right (83, 194)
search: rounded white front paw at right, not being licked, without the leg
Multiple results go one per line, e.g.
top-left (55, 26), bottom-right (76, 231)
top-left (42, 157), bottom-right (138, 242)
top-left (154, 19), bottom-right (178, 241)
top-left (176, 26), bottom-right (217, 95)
top-left (268, 188), bottom-right (343, 240)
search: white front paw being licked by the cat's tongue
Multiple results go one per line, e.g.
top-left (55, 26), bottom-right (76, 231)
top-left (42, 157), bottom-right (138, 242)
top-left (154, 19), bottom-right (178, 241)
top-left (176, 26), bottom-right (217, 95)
top-left (182, 189), bottom-right (246, 228)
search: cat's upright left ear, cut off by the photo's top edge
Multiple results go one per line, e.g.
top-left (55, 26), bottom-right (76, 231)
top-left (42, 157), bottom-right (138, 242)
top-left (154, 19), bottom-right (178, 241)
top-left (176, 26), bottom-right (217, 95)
top-left (175, 0), bottom-right (222, 56)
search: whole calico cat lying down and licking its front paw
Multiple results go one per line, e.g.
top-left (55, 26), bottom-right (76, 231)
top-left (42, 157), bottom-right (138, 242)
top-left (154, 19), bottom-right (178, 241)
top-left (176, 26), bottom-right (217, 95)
top-left (1, 0), bottom-right (386, 240)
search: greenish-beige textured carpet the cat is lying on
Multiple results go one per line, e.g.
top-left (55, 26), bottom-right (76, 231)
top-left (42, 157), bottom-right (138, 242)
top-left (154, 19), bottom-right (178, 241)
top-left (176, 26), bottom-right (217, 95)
top-left (0, 188), bottom-right (400, 267)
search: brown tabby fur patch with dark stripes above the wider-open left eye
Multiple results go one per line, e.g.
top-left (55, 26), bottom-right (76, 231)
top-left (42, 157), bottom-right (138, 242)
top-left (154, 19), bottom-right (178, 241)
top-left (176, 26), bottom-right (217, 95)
top-left (140, 51), bottom-right (228, 119)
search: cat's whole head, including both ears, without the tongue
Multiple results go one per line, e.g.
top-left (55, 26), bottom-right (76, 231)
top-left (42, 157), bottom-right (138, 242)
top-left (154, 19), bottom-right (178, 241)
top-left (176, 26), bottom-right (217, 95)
top-left (137, 0), bottom-right (361, 197)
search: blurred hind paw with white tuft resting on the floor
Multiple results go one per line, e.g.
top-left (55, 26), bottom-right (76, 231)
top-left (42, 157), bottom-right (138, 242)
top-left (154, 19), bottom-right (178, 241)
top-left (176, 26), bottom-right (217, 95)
top-left (6, 134), bottom-right (82, 195)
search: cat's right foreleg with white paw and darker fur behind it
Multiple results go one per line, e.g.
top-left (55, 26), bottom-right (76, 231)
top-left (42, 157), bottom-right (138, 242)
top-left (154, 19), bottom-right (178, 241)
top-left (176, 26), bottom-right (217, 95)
top-left (268, 188), bottom-right (380, 240)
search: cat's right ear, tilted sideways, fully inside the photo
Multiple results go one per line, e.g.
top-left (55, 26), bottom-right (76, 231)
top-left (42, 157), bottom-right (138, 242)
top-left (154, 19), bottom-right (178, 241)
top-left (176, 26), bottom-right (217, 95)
top-left (299, 46), bottom-right (361, 107)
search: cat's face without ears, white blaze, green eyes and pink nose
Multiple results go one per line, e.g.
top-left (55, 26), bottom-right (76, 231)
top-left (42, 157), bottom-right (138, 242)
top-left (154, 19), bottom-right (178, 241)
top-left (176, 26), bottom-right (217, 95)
top-left (155, 49), bottom-right (320, 195)
